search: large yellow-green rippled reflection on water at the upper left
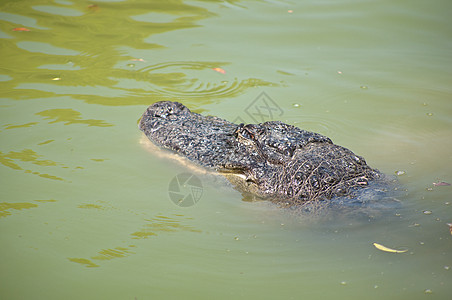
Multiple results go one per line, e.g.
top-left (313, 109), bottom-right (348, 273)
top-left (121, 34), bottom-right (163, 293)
top-left (0, 1), bottom-right (276, 105)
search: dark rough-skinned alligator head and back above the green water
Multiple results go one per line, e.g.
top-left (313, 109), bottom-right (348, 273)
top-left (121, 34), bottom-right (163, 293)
top-left (139, 101), bottom-right (396, 207)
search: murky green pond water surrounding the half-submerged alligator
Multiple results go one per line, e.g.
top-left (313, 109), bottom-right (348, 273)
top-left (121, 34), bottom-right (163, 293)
top-left (0, 0), bottom-right (452, 299)
